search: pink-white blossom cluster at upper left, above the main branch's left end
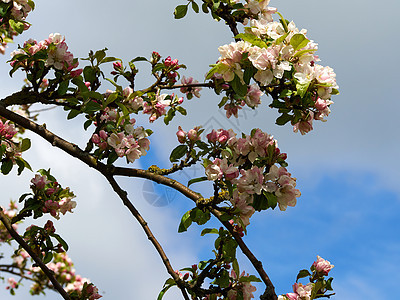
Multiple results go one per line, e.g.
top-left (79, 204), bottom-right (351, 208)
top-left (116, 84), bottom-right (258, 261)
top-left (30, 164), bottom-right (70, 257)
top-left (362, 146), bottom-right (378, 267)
top-left (10, 33), bottom-right (82, 84)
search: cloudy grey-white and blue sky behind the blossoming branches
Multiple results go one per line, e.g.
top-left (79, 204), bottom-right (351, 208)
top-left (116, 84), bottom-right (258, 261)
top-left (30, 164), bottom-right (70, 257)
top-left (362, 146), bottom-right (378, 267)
top-left (0, 0), bottom-right (400, 300)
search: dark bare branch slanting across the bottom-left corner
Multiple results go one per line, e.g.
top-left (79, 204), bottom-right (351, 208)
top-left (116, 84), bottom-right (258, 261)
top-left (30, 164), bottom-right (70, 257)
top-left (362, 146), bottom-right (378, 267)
top-left (0, 207), bottom-right (71, 300)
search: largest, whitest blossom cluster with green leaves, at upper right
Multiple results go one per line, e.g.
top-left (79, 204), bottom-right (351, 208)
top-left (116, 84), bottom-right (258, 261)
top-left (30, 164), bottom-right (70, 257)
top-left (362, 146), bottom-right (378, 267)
top-left (207, 0), bottom-right (338, 134)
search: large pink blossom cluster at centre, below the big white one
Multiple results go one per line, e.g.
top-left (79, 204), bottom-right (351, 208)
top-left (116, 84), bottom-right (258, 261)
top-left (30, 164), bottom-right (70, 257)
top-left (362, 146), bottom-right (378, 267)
top-left (176, 127), bottom-right (300, 227)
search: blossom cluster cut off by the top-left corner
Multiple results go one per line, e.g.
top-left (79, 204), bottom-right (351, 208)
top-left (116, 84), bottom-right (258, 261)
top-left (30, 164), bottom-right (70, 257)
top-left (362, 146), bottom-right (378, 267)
top-left (0, 0), bottom-right (35, 54)
